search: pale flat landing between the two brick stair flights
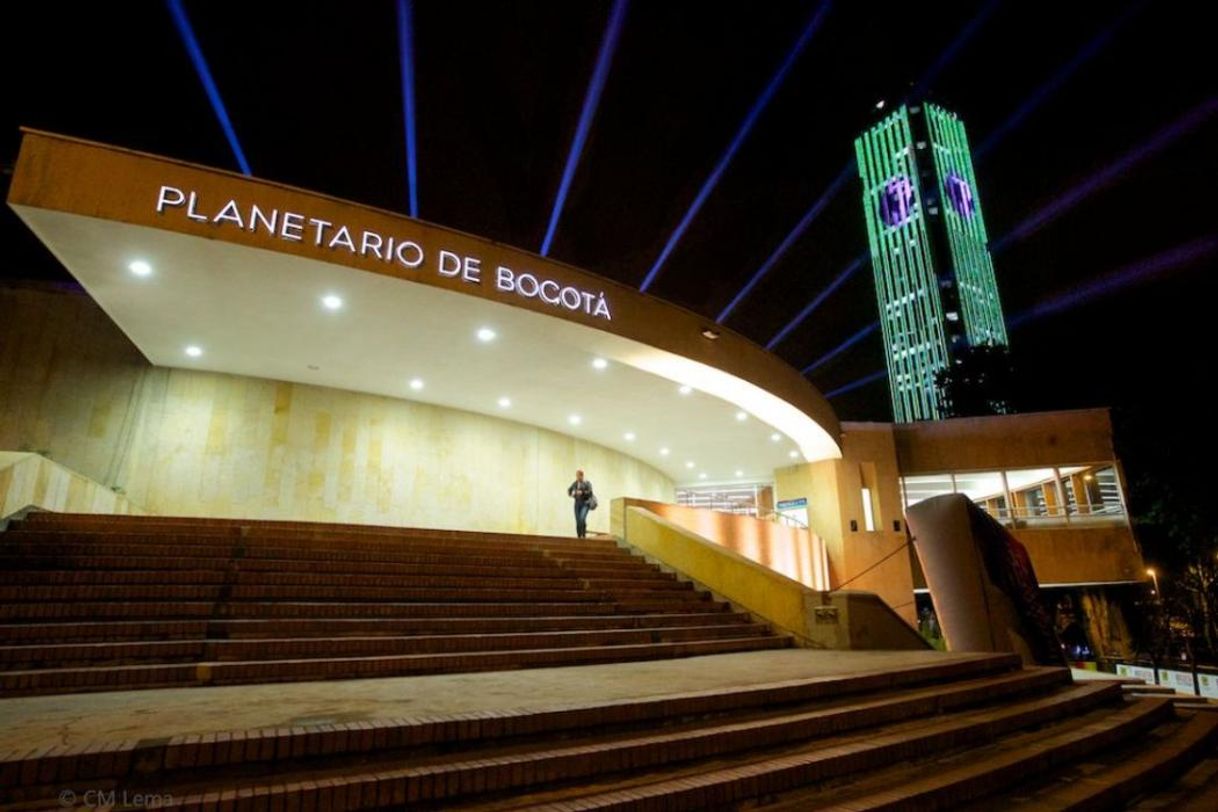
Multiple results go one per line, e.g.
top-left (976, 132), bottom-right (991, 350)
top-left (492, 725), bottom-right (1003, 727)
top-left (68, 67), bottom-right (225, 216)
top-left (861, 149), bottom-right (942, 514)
top-left (0, 649), bottom-right (974, 751)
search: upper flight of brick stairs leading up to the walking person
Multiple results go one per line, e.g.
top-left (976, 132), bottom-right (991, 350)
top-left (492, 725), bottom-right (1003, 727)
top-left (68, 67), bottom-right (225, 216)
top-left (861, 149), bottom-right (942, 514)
top-left (0, 514), bottom-right (790, 696)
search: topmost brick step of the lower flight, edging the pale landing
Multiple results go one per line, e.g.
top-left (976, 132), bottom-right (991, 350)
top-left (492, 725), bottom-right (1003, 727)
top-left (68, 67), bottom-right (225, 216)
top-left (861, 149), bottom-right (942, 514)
top-left (0, 655), bottom-right (1027, 801)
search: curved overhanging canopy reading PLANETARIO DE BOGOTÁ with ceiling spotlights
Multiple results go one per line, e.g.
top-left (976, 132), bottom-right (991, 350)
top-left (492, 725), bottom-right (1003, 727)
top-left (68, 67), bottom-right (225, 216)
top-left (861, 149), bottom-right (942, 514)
top-left (9, 130), bottom-right (840, 485)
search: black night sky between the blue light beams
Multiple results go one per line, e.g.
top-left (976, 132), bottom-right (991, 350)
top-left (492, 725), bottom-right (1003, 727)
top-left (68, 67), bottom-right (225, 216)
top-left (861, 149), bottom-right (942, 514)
top-left (0, 0), bottom-right (1218, 457)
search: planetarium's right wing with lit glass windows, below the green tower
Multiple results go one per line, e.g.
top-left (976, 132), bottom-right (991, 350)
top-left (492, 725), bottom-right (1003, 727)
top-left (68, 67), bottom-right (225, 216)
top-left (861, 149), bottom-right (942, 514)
top-left (775, 409), bottom-right (1146, 656)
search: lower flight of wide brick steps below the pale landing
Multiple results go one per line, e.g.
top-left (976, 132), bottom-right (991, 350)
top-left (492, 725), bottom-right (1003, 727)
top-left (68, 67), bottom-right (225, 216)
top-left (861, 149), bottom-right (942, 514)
top-left (0, 655), bottom-right (1218, 811)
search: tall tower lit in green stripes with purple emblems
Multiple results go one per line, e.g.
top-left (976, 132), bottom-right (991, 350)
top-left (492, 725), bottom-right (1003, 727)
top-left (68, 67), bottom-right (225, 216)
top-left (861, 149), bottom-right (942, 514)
top-left (854, 103), bottom-right (1007, 422)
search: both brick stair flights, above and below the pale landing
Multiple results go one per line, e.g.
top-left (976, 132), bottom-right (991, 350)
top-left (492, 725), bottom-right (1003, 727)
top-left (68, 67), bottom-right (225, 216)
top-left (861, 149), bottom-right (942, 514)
top-left (0, 516), bottom-right (1218, 811)
